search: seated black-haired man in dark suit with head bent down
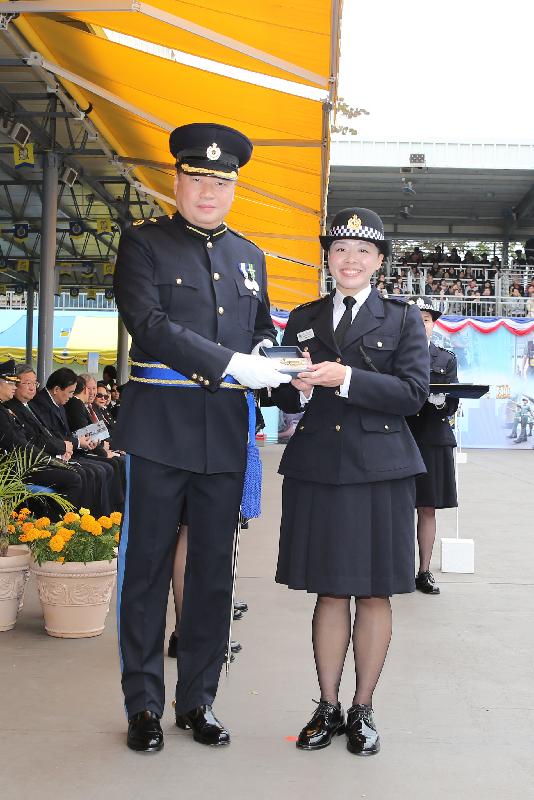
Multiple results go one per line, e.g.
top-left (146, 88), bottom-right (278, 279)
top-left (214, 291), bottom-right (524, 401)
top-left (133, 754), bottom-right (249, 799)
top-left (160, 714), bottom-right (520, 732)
top-left (30, 367), bottom-right (124, 513)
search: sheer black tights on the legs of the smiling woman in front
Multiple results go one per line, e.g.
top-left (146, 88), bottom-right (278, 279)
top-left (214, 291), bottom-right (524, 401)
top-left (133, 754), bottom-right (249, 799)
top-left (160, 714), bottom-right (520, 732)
top-left (312, 595), bottom-right (391, 705)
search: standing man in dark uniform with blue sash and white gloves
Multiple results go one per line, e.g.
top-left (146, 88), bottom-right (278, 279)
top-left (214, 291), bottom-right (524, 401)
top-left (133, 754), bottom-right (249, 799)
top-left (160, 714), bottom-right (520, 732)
top-left (114, 124), bottom-right (289, 751)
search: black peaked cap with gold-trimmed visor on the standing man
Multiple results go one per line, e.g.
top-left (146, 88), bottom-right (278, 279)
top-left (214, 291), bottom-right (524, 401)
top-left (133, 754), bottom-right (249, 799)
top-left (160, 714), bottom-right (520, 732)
top-left (169, 122), bottom-right (252, 181)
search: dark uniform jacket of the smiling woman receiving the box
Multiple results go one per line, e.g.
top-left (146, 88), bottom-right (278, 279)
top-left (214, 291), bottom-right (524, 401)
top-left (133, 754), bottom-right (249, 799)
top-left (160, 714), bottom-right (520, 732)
top-left (272, 289), bottom-right (428, 484)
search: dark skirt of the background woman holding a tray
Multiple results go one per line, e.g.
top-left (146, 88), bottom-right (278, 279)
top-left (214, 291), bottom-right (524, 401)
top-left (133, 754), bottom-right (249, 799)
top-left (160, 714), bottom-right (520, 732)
top-left (415, 442), bottom-right (458, 508)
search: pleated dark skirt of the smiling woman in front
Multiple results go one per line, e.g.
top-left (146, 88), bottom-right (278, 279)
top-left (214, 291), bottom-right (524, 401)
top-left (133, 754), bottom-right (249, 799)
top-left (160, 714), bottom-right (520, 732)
top-left (276, 478), bottom-right (415, 597)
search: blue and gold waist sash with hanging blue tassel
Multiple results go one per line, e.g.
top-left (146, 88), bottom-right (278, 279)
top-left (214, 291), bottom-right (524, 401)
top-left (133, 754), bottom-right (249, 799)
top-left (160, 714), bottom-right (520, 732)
top-left (130, 361), bottom-right (262, 519)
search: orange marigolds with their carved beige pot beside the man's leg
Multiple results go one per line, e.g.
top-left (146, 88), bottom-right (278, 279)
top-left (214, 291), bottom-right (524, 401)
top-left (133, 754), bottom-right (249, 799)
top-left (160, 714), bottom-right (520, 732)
top-left (15, 508), bottom-right (122, 639)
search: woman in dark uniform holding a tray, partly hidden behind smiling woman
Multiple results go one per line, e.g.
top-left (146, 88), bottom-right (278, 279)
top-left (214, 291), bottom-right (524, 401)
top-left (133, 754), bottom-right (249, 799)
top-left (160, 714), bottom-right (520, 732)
top-left (406, 297), bottom-right (459, 595)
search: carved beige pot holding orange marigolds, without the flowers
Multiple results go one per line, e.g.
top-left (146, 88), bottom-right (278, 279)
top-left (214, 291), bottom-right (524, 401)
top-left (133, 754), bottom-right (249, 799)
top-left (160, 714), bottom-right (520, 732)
top-left (31, 558), bottom-right (117, 639)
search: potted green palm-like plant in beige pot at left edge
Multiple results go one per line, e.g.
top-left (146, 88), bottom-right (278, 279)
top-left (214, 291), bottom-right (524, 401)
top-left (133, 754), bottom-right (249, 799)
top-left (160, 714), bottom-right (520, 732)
top-left (0, 450), bottom-right (71, 631)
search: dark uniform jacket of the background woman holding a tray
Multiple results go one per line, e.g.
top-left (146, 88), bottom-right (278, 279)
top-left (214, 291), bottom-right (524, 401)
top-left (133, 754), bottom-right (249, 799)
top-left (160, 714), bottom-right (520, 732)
top-left (406, 342), bottom-right (459, 447)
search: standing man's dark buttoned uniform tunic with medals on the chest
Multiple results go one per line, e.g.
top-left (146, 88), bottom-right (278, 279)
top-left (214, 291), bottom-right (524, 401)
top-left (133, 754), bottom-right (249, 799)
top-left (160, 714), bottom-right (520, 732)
top-left (113, 214), bottom-right (276, 473)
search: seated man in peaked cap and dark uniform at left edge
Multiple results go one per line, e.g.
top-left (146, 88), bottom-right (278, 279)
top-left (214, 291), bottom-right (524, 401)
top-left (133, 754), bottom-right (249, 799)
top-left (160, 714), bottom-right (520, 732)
top-left (0, 360), bottom-right (82, 514)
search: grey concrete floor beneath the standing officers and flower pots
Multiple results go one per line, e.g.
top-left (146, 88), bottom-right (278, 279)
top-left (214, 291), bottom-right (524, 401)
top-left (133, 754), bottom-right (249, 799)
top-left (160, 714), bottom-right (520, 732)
top-left (0, 445), bottom-right (534, 800)
